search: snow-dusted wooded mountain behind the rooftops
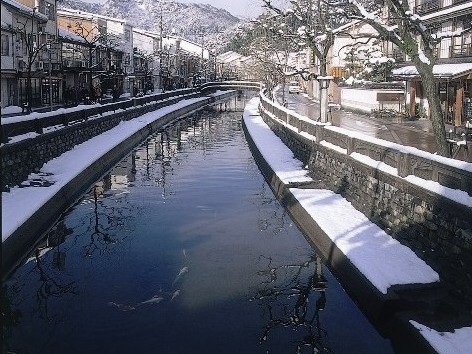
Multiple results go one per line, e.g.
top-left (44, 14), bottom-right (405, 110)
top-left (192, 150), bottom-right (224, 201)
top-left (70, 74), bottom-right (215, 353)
top-left (58, 0), bottom-right (244, 50)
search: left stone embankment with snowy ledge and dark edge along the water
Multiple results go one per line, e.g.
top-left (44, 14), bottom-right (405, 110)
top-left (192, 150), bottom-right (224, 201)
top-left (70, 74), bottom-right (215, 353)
top-left (2, 91), bottom-right (235, 277)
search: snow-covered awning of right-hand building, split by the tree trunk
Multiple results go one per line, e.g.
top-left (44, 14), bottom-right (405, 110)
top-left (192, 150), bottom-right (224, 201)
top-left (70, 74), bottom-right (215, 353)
top-left (392, 63), bottom-right (472, 80)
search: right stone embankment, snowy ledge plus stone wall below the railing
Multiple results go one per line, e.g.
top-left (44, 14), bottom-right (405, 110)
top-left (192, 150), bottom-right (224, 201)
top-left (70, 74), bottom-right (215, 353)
top-left (244, 95), bottom-right (472, 353)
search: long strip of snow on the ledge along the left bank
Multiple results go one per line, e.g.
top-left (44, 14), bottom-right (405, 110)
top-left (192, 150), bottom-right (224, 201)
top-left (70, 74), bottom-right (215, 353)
top-left (2, 97), bottom-right (206, 242)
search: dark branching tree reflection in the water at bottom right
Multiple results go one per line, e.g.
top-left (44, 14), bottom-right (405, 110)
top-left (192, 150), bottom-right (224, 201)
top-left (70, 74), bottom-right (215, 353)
top-left (251, 255), bottom-right (331, 353)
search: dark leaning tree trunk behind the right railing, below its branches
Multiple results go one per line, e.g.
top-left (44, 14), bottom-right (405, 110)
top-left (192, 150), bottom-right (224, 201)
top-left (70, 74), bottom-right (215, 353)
top-left (415, 62), bottom-right (451, 157)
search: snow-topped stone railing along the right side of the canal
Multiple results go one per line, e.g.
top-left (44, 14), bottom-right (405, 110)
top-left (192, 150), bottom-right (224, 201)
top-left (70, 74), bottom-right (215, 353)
top-left (260, 91), bottom-right (472, 196)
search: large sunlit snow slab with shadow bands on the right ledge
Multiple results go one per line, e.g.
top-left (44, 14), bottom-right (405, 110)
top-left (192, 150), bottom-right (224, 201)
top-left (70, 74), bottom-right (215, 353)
top-left (290, 188), bottom-right (439, 294)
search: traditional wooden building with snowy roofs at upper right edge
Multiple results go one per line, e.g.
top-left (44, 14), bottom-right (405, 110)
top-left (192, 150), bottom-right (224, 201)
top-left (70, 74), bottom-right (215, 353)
top-left (393, 0), bottom-right (472, 126)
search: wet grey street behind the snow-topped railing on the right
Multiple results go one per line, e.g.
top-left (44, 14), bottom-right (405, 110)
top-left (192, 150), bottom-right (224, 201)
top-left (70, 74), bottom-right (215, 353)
top-left (279, 93), bottom-right (472, 162)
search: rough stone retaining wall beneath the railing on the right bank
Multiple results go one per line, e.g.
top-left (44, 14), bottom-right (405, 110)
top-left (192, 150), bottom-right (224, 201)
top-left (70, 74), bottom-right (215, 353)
top-left (260, 100), bottom-right (472, 306)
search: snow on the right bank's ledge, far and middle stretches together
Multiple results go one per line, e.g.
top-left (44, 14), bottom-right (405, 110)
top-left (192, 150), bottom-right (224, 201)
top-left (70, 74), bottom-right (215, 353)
top-left (244, 99), bottom-right (439, 294)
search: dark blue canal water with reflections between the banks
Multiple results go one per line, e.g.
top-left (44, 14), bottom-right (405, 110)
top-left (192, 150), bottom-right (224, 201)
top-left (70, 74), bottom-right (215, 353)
top-left (3, 95), bottom-right (392, 353)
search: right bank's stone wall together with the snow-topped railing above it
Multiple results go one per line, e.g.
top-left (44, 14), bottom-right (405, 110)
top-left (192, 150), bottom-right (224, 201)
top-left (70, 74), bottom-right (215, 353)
top-left (259, 92), bottom-right (472, 306)
